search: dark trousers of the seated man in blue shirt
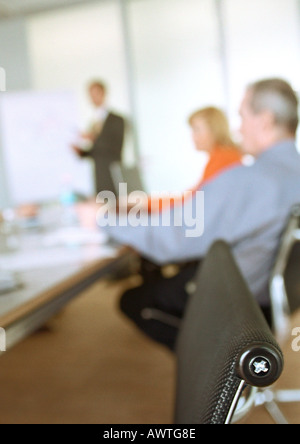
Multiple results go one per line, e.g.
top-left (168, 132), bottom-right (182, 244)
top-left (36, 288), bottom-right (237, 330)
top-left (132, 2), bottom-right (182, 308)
top-left (120, 262), bottom-right (199, 350)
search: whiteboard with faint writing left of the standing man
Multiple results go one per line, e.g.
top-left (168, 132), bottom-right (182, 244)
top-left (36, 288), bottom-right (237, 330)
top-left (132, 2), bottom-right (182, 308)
top-left (0, 91), bottom-right (93, 204)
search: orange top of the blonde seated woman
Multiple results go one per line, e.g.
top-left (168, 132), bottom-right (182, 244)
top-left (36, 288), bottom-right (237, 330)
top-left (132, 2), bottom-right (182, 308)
top-left (148, 146), bottom-right (243, 212)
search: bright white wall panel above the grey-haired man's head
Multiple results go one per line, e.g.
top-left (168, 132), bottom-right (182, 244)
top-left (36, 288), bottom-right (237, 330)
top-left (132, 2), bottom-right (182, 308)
top-left (224, 0), bottom-right (300, 137)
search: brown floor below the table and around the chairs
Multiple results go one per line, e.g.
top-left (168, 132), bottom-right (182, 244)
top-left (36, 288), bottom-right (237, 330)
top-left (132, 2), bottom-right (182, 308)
top-left (0, 283), bottom-right (300, 424)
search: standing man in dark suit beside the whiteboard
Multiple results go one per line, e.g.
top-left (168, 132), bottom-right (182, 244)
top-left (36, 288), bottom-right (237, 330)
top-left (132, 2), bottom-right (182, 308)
top-left (73, 81), bottom-right (125, 194)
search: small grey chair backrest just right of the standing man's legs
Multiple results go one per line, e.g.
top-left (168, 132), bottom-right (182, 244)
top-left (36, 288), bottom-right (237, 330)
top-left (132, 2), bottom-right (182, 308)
top-left (110, 162), bottom-right (145, 193)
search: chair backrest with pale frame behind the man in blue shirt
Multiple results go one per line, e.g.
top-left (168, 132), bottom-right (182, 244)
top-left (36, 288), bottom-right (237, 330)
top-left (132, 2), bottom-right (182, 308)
top-left (270, 204), bottom-right (300, 340)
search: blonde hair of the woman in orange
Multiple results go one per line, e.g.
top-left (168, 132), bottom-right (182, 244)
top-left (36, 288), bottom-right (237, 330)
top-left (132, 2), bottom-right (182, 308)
top-left (189, 106), bottom-right (237, 148)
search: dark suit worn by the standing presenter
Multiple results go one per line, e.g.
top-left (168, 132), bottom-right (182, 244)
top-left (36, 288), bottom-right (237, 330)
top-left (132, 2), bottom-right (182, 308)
top-left (80, 113), bottom-right (125, 195)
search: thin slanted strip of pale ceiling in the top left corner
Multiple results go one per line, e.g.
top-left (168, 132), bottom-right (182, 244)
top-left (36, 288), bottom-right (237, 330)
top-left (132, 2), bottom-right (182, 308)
top-left (0, 0), bottom-right (103, 20)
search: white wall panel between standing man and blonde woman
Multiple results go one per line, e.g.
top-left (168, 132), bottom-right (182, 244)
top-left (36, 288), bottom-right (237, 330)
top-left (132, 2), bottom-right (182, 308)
top-left (129, 0), bottom-right (224, 191)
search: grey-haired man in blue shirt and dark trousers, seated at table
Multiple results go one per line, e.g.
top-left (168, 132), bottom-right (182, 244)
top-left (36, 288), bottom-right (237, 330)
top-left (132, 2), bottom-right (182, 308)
top-left (104, 79), bottom-right (300, 349)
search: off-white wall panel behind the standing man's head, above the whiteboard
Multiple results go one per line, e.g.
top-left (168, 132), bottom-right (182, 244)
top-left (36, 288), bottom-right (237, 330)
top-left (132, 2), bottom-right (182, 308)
top-left (27, 0), bottom-right (130, 130)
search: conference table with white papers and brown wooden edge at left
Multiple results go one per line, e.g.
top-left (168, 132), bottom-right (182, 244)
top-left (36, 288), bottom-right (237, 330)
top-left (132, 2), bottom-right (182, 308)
top-left (0, 210), bottom-right (135, 355)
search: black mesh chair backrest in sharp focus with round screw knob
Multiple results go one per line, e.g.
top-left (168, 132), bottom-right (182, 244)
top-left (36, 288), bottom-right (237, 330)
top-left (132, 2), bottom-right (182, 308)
top-left (175, 241), bottom-right (283, 424)
